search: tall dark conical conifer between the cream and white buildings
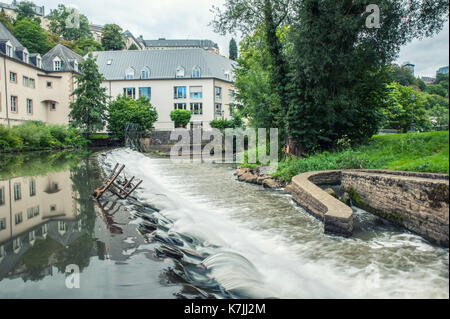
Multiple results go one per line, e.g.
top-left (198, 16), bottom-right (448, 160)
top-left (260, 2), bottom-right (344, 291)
top-left (70, 53), bottom-right (107, 134)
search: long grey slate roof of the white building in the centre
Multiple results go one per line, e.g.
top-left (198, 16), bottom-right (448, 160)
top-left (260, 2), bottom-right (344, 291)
top-left (94, 48), bottom-right (237, 81)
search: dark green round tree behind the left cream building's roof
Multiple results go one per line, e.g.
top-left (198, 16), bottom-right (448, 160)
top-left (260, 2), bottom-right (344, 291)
top-left (13, 18), bottom-right (52, 55)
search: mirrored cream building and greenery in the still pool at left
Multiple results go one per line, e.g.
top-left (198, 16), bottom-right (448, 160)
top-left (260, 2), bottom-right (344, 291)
top-left (0, 152), bottom-right (95, 281)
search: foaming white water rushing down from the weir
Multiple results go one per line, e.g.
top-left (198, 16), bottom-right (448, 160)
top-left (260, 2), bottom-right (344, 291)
top-left (102, 149), bottom-right (449, 298)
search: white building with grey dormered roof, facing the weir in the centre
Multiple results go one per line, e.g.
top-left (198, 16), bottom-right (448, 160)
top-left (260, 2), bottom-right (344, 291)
top-left (94, 49), bottom-right (236, 130)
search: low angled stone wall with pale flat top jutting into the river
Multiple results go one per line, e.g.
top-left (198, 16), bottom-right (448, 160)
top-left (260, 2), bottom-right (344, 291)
top-left (285, 171), bottom-right (353, 236)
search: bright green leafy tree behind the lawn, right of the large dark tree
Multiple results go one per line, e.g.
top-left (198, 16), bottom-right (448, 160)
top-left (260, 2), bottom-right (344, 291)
top-left (383, 83), bottom-right (431, 132)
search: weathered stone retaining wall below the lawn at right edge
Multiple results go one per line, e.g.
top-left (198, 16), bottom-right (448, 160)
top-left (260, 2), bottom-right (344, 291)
top-left (341, 170), bottom-right (449, 247)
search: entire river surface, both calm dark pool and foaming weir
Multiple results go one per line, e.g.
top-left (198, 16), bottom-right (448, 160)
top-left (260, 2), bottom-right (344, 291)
top-left (0, 149), bottom-right (449, 298)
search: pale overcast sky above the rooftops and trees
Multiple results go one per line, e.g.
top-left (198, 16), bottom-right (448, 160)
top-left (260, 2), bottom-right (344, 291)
top-left (36, 0), bottom-right (449, 76)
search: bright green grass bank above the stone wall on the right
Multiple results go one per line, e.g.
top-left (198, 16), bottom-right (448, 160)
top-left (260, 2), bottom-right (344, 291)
top-left (274, 131), bottom-right (449, 181)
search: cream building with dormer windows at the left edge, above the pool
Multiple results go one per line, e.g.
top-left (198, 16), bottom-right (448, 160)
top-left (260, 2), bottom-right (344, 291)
top-left (0, 23), bottom-right (82, 126)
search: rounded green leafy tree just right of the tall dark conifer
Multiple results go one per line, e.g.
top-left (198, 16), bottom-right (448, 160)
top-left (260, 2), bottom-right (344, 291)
top-left (108, 96), bottom-right (158, 139)
